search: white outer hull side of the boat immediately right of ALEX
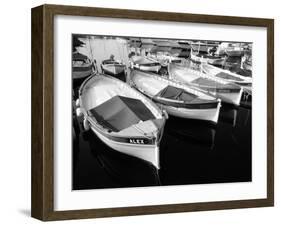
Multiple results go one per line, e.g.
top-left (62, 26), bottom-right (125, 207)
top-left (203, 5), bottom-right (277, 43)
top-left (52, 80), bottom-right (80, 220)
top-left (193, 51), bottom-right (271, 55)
top-left (161, 104), bottom-right (221, 123)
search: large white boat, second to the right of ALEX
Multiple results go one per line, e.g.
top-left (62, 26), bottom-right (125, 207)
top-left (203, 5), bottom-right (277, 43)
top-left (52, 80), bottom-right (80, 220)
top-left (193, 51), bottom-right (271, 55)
top-left (168, 64), bottom-right (243, 105)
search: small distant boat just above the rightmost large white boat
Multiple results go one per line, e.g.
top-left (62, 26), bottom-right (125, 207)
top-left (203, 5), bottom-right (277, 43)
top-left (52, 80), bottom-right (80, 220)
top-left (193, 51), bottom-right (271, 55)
top-left (190, 50), bottom-right (226, 66)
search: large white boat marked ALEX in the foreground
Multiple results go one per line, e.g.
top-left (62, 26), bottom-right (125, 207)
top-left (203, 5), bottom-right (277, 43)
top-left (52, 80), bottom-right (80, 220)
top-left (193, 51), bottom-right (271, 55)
top-left (76, 74), bottom-right (167, 169)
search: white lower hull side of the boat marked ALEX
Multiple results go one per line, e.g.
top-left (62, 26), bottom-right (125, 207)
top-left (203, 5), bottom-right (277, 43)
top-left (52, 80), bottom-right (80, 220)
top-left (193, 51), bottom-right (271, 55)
top-left (91, 127), bottom-right (160, 169)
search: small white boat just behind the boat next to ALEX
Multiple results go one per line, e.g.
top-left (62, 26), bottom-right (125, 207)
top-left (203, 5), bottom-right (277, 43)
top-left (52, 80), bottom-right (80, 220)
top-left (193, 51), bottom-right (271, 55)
top-left (131, 56), bottom-right (161, 72)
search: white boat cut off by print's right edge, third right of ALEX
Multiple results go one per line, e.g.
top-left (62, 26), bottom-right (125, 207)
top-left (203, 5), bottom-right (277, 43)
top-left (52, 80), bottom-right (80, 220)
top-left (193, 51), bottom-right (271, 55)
top-left (201, 64), bottom-right (252, 86)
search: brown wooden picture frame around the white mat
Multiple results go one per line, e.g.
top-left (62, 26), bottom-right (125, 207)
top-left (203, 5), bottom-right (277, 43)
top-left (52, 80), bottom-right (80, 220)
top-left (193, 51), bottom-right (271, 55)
top-left (31, 5), bottom-right (274, 221)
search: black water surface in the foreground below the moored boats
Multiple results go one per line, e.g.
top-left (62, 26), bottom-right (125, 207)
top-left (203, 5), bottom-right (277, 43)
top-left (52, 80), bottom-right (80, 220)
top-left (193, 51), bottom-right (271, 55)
top-left (72, 98), bottom-right (252, 190)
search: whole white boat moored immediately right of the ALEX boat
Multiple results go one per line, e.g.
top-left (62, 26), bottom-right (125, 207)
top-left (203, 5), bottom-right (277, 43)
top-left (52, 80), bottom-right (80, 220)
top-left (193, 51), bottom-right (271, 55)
top-left (130, 70), bottom-right (221, 123)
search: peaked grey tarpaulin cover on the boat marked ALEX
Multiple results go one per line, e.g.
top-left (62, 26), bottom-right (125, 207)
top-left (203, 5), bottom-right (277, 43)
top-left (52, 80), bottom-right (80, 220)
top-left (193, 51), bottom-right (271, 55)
top-left (90, 96), bottom-right (155, 132)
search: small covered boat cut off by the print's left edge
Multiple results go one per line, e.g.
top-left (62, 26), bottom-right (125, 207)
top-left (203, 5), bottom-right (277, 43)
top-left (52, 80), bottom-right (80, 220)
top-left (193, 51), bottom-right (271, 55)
top-left (72, 52), bottom-right (93, 80)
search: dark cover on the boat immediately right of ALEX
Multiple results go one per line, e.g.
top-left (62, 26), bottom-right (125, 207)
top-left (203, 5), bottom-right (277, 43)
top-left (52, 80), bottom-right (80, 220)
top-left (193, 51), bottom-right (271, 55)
top-left (155, 85), bottom-right (198, 102)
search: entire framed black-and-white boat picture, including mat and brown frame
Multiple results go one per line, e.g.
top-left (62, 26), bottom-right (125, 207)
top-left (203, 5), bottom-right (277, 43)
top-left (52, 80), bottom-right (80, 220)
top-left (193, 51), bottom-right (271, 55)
top-left (31, 5), bottom-right (274, 221)
